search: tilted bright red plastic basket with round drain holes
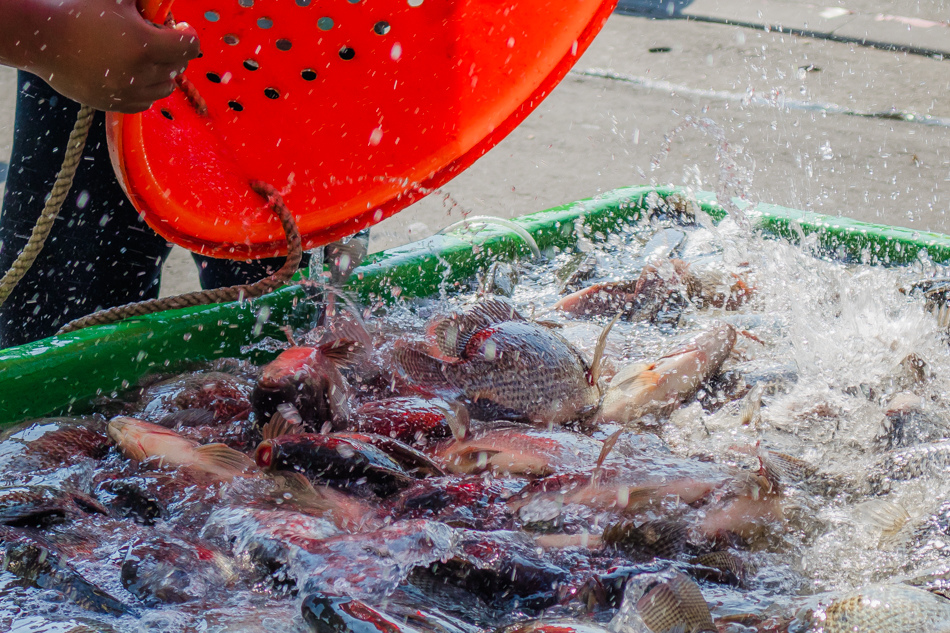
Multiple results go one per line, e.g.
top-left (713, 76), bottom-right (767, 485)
top-left (109, 0), bottom-right (616, 259)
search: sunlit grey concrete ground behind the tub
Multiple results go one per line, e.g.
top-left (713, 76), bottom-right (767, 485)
top-left (0, 0), bottom-right (950, 294)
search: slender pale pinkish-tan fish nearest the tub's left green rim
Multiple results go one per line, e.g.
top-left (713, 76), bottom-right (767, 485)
top-left (108, 416), bottom-right (257, 481)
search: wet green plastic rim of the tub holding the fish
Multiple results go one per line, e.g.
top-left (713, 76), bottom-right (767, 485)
top-left (0, 187), bottom-right (950, 426)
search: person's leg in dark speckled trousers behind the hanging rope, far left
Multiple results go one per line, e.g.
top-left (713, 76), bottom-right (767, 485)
top-left (0, 72), bottom-right (169, 348)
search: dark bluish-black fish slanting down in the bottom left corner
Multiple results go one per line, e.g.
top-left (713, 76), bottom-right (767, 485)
top-left (0, 526), bottom-right (135, 615)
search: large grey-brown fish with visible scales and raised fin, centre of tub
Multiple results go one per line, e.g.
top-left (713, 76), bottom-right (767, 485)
top-left (393, 299), bottom-right (600, 426)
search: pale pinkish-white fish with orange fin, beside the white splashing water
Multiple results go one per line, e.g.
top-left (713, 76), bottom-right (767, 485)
top-left (596, 322), bottom-right (737, 425)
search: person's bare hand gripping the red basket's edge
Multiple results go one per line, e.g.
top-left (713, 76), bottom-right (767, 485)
top-left (0, 0), bottom-right (200, 113)
